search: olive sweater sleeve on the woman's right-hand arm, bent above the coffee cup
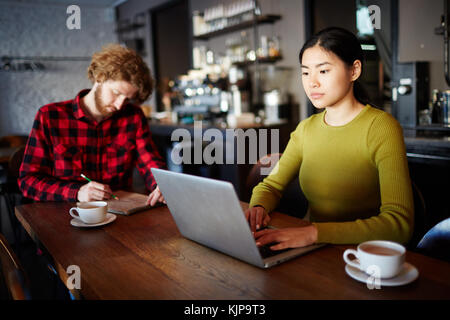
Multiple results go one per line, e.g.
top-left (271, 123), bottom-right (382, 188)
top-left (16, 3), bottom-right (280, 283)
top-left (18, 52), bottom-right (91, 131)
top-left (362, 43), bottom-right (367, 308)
top-left (314, 113), bottom-right (414, 244)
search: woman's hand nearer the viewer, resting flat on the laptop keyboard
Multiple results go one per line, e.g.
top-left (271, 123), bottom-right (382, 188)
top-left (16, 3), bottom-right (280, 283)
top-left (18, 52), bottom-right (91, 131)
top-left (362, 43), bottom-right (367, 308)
top-left (255, 225), bottom-right (317, 250)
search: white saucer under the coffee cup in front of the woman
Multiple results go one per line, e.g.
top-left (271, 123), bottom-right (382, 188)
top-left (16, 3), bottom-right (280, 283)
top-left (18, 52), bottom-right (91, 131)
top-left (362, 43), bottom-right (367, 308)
top-left (345, 262), bottom-right (419, 287)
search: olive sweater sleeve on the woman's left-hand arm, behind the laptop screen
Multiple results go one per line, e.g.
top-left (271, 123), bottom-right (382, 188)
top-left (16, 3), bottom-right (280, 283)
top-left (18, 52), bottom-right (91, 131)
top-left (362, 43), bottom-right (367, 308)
top-left (249, 121), bottom-right (306, 212)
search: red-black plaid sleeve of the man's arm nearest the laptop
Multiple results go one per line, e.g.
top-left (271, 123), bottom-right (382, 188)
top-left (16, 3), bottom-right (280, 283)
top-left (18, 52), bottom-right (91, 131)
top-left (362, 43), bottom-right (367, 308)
top-left (136, 110), bottom-right (166, 190)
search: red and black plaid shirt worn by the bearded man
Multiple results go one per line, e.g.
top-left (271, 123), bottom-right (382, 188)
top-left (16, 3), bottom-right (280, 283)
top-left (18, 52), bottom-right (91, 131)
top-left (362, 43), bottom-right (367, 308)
top-left (18, 90), bottom-right (165, 201)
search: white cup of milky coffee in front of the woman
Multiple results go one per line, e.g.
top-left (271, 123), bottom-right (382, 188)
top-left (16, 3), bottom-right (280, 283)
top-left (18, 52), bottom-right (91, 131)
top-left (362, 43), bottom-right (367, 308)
top-left (343, 240), bottom-right (406, 279)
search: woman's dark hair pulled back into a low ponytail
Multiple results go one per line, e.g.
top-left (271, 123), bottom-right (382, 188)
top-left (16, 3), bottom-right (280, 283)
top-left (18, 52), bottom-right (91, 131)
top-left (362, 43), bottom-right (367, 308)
top-left (298, 27), bottom-right (369, 104)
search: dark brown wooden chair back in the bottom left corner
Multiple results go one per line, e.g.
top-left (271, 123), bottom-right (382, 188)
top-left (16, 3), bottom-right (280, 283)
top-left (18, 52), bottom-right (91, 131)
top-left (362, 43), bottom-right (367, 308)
top-left (0, 234), bottom-right (31, 300)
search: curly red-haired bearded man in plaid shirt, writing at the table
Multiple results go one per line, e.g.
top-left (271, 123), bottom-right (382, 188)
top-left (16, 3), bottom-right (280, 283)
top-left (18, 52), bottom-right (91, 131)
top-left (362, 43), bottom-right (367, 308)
top-left (18, 44), bottom-right (165, 205)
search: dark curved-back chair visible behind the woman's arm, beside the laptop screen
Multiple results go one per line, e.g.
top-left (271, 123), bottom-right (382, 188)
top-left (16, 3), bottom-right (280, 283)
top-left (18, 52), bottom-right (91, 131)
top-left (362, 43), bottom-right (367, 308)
top-left (246, 153), bottom-right (308, 218)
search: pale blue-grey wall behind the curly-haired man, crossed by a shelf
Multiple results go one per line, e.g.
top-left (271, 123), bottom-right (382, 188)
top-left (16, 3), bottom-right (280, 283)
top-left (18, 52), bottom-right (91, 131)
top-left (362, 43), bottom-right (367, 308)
top-left (0, 1), bottom-right (117, 135)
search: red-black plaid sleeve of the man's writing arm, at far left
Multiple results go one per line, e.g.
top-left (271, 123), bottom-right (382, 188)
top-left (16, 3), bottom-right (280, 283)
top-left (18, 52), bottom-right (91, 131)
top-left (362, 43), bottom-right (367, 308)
top-left (18, 110), bottom-right (82, 201)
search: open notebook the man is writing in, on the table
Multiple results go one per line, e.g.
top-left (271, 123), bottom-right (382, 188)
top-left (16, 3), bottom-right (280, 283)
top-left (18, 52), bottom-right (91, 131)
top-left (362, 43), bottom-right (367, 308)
top-left (107, 190), bottom-right (160, 215)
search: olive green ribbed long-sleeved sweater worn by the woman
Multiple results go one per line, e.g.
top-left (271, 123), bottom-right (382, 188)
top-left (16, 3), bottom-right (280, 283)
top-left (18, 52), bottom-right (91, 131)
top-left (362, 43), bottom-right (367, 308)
top-left (250, 105), bottom-right (414, 244)
